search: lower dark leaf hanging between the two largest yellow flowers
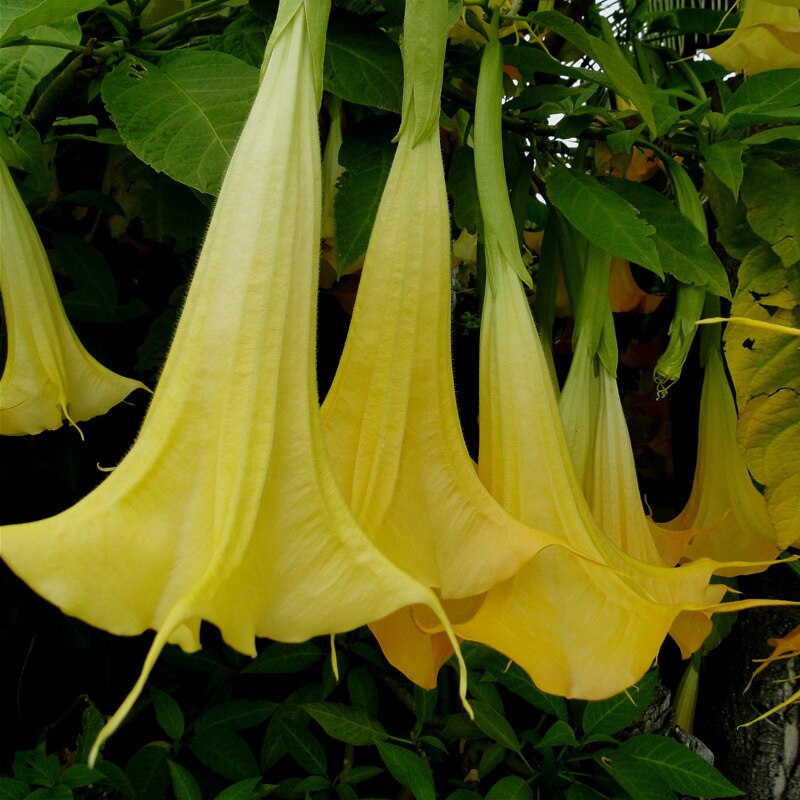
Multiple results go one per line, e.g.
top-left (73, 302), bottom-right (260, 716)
top-left (333, 130), bottom-right (395, 275)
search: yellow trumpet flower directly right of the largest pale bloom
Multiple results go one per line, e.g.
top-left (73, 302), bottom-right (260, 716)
top-left (322, 0), bottom-right (560, 686)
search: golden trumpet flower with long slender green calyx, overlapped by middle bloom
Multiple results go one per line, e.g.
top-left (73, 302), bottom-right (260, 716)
top-left (373, 20), bottom-right (792, 699)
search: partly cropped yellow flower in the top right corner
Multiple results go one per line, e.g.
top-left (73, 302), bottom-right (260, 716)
top-left (705, 0), bottom-right (800, 75)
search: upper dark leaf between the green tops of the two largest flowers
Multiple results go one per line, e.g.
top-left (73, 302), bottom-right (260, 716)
top-left (323, 18), bottom-right (403, 112)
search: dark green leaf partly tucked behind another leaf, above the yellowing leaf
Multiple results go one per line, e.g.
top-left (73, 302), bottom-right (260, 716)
top-left (605, 178), bottom-right (730, 297)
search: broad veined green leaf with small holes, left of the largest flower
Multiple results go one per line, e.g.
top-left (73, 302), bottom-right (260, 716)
top-left (102, 50), bottom-right (258, 194)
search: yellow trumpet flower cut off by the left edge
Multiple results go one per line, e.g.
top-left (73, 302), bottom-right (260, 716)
top-left (0, 159), bottom-right (147, 436)
